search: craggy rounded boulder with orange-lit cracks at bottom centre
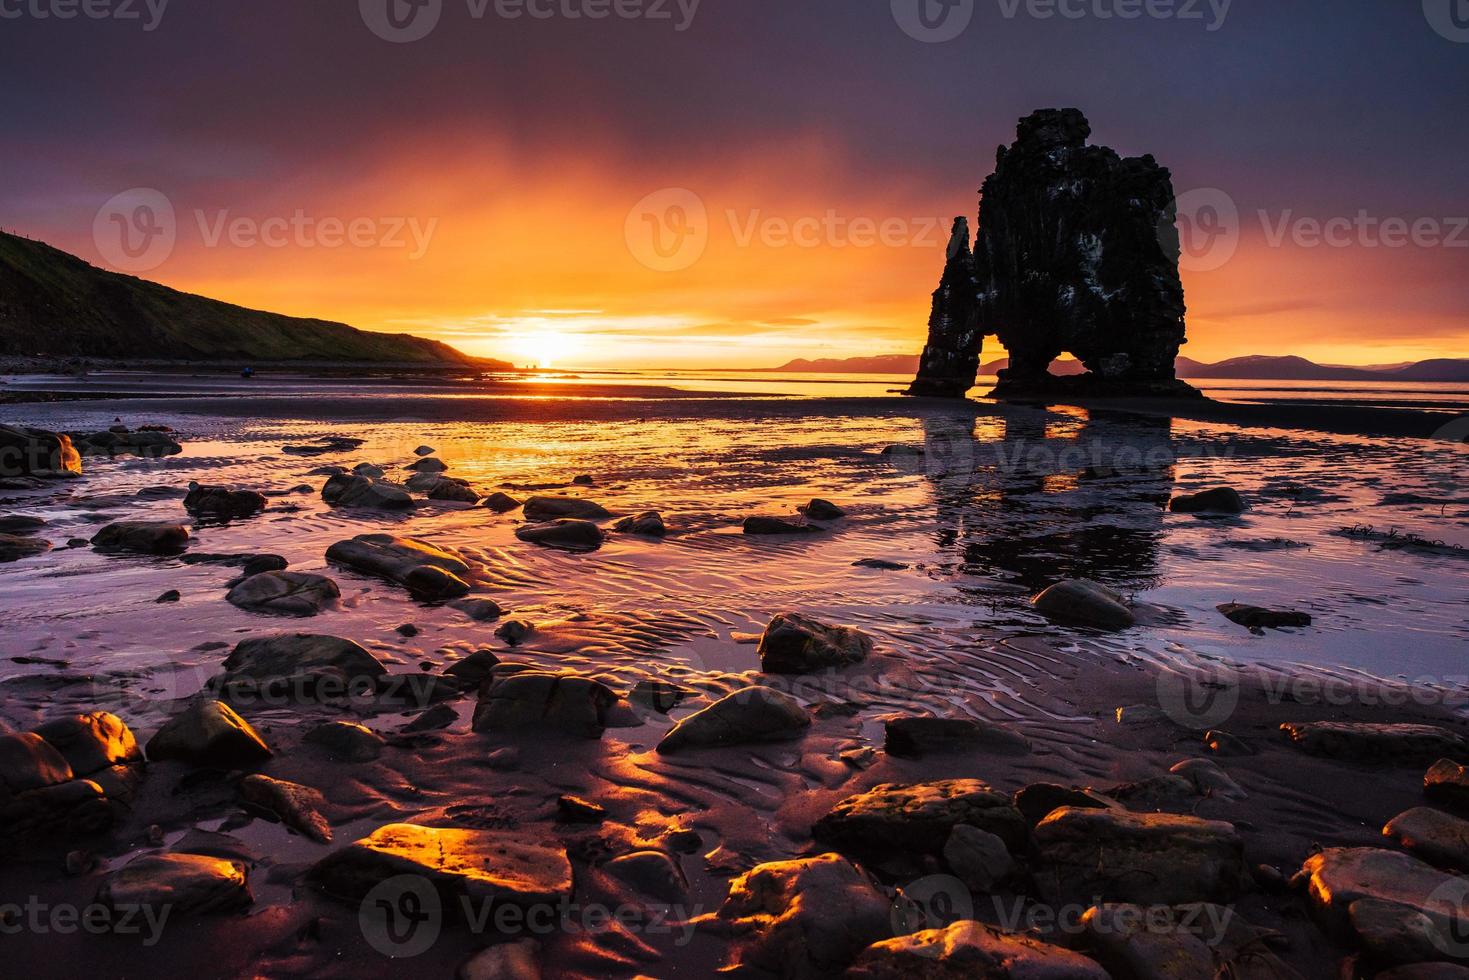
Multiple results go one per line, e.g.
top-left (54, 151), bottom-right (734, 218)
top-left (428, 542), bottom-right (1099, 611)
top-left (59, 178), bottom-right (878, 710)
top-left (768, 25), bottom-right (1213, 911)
top-left (717, 854), bottom-right (892, 977)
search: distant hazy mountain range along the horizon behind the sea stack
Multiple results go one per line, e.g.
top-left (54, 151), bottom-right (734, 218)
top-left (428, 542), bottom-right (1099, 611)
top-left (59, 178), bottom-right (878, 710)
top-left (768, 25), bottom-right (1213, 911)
top-left (774, 354), bottom-right (1469, 382)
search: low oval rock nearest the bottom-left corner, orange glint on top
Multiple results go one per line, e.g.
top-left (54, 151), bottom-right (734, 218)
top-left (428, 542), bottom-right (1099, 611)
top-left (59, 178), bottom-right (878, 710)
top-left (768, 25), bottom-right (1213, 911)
top-left (97, 854), bottom-right (254, 915)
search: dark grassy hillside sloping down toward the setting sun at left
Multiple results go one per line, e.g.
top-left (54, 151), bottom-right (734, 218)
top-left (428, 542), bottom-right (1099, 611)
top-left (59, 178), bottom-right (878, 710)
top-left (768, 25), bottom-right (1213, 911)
top-left (0, 232), bottom-right (499, 370)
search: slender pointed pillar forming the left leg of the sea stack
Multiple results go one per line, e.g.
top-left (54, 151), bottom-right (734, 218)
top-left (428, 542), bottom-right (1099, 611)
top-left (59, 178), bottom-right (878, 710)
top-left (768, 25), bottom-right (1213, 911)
top-left (908, 217), bottom-right (984, 398)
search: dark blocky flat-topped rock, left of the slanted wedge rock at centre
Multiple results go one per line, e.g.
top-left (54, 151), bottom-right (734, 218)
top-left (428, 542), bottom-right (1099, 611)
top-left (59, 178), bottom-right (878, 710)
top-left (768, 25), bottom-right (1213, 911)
top-left (473, 670), bottom-right (617, 739)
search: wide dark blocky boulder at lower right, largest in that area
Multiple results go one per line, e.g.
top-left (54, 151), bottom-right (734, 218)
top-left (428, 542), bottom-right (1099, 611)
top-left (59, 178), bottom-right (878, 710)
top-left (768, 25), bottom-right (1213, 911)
top-left (1033, 807), bottom-right (1246, 905)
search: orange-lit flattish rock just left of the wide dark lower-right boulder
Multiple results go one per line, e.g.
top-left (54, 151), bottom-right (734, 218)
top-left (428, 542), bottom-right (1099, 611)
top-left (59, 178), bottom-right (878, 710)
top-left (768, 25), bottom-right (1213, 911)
top-left (811, 779), bottom-right (1025, 855)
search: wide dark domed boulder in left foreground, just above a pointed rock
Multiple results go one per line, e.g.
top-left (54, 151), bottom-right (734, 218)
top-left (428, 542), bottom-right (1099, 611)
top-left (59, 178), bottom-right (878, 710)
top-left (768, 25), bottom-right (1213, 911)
top-left (219, 633), bottom-right (388, 704)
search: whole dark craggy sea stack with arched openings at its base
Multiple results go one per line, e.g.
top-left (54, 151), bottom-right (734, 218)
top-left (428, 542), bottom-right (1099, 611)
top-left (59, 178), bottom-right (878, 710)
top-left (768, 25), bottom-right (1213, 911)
top-left (909, 109), bottom-right (1197, 397)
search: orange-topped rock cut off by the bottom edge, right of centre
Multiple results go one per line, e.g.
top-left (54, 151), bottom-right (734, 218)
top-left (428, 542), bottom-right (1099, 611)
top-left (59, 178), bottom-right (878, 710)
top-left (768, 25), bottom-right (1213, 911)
top-left (846, 921), bottom-right (1104, 980)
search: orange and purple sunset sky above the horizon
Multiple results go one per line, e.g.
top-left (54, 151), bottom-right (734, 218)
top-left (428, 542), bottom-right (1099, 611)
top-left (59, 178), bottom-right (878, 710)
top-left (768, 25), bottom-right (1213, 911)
top-left (0, 0), bottom-right (1469, 367)
